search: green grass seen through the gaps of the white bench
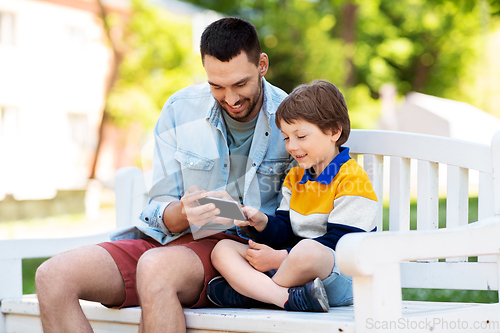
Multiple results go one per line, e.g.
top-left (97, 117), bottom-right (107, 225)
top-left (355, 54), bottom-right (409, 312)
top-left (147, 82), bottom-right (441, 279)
top-left (18, 198), bottom-right (498, 303)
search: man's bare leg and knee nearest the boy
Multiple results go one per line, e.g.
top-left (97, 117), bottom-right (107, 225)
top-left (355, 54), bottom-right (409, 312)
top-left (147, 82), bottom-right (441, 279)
top-left (137, 246), bottom-right (205, 333)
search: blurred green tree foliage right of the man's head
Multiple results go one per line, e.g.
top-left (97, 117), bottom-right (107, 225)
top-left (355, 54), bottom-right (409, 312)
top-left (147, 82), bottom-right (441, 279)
top-left (182, 0), bottom-right (494, 127)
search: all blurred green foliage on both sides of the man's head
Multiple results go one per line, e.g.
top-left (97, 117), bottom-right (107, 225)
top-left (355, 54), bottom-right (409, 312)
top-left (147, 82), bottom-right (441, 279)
top-left (107, 0), bottom-right (500, 128)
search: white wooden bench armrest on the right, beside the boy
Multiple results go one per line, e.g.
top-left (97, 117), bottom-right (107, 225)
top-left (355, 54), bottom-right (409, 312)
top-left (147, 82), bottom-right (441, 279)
top-left (336, 215), bottom-right (500, 276)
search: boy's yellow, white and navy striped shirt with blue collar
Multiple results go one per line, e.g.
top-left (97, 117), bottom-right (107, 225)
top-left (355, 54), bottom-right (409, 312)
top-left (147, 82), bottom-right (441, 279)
top-left (249, 147), bottom-right (378, 251)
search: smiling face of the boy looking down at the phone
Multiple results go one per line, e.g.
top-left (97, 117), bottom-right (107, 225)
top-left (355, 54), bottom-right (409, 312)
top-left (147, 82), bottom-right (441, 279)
top-left (280, 120), bottom-right (342, 175)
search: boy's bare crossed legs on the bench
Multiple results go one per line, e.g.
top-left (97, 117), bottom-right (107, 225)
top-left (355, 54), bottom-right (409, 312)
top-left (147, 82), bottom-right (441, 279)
top-left (212, 240), bottom-right (334, 308)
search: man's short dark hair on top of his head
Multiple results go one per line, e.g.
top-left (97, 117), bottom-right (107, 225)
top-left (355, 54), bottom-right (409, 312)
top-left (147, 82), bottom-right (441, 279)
top-left (200, 17), bottom-right (262, 66)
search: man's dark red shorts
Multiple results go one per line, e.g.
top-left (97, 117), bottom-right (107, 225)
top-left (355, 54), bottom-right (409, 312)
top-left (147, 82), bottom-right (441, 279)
top-left (97, 232), bottom-right (248, 308)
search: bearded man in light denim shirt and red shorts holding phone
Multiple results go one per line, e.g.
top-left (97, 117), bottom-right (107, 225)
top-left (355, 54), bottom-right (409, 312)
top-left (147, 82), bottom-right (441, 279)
top-left (36, 18), bottom-right (291, 332)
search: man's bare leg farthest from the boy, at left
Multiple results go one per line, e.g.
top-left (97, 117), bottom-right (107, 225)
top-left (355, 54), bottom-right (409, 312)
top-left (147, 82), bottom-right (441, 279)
top-left (35, 245), bottom-right (125, 333)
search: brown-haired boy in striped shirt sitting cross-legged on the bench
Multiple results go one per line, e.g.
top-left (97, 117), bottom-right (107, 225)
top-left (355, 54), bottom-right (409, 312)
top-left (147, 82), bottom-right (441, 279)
top-left (207, 81), bottom-right (377, 312)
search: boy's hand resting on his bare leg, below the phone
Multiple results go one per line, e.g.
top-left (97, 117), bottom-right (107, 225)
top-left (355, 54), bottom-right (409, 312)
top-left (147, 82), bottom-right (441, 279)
top-left (246, 239), bottom-right (288, 272)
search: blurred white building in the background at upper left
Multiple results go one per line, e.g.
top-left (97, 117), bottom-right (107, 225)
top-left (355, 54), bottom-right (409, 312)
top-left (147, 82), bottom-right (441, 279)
top-left (0, 0), bottom-right (127, 200)
